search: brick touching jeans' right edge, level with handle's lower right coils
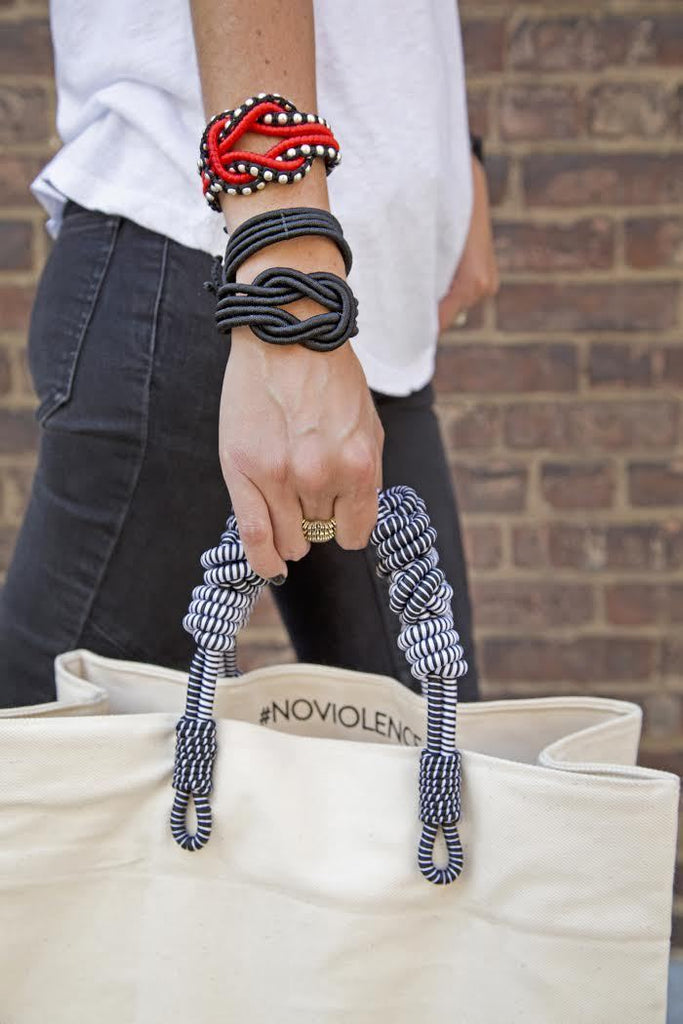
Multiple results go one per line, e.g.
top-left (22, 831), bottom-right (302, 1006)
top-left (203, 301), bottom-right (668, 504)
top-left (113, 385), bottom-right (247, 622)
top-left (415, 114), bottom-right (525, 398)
top-left (472, 580), bottom-right (594, 630)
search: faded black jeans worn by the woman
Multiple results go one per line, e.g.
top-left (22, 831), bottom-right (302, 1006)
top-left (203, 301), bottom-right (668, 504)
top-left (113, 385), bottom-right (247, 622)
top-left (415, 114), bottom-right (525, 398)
top-left (0, 203), bottom-right (477, 707)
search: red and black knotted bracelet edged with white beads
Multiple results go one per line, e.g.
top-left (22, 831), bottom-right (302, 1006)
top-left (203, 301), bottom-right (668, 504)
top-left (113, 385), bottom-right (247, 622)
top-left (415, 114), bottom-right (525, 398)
top-left (199, 92), bottom-right (341, 212)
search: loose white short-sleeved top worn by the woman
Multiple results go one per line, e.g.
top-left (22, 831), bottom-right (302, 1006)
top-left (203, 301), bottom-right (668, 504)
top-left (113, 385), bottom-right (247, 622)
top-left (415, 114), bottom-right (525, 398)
top-left (32, 0), bottom-right (472, 394)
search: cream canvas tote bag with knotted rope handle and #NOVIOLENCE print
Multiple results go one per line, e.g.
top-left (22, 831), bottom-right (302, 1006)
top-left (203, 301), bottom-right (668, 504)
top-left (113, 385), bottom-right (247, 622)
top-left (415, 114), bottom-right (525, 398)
top-left (0, 488), bottom-right (678, 1024)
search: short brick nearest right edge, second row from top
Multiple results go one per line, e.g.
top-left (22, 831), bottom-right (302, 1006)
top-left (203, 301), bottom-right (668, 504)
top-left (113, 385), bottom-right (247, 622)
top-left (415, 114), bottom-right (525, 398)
top-left (588, 82), bottom-right (672, 138)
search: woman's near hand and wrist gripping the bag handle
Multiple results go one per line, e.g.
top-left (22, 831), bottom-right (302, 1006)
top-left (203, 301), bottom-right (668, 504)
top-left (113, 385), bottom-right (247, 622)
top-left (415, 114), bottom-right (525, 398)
top-left (219, 239), bottom-right (384, 579)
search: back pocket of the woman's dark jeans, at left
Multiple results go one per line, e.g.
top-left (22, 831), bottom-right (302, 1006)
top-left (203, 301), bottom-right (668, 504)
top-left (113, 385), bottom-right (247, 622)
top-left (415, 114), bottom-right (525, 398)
top-left (29, 208), bottom-right (121, 426)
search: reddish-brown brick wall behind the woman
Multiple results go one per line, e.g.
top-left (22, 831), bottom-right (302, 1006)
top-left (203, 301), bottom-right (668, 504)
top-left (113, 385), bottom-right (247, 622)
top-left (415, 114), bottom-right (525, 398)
top-left (0, 0), bottom-right (683, 942)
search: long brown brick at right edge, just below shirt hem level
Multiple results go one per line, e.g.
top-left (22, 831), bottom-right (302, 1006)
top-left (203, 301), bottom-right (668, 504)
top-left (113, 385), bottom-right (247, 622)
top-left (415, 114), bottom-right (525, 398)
top-left (505, 400), bottom-right (679, 452)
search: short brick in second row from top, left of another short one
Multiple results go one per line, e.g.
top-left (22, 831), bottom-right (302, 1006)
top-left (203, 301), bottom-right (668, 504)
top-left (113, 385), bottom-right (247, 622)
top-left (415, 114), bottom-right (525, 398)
top-left (499, 82), bottom-right (581, 142)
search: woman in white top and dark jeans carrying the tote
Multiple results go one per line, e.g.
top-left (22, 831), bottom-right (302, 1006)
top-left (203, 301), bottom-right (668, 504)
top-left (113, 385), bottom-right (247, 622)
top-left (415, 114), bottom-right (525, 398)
top-left (0, 0), bottom-right (497, 706)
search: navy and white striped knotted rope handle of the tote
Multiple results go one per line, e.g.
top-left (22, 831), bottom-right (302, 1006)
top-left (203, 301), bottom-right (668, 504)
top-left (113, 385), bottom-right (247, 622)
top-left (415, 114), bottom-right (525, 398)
top-left (171, 486), bottom-right (467, 885)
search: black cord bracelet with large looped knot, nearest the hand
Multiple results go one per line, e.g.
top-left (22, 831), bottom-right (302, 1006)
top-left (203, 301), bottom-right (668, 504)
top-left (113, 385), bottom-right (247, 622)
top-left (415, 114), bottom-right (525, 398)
top-left (216, 266), bottom-right (358, 352)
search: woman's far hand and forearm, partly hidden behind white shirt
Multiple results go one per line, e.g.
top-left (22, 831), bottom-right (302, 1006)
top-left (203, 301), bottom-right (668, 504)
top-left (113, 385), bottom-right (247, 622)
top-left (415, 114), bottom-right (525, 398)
top-left (438, 151), bottom-right (499, 331)
